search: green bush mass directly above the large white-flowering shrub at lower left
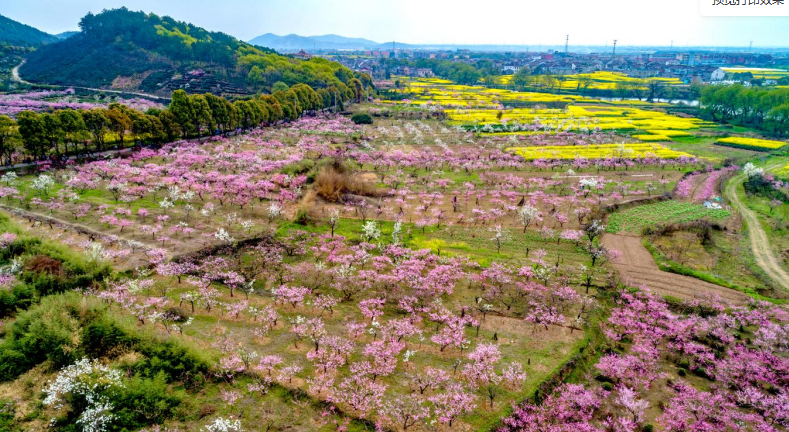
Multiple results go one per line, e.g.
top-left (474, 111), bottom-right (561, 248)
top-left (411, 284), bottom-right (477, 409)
top-left (0, 292), bottom-right (211, 385)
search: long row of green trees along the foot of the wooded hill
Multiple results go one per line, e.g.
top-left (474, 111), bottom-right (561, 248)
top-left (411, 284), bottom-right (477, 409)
top-left (0, 78), bottom-right (367, 162)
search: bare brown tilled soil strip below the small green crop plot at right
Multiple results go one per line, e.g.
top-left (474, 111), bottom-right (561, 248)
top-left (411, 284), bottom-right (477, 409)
top-left (602, 234), bottom-right (748, 304)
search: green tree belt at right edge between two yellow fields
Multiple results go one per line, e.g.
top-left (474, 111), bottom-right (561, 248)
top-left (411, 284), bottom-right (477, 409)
top-left (699, 84), bottom-right (789, 136)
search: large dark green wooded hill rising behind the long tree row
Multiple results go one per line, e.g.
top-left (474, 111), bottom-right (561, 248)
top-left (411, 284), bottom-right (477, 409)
top-left (19, 8), bottom-right (353, 95)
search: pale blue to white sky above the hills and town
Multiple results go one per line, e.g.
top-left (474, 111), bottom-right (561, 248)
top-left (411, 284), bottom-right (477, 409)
top-left (0, 0), bottom-right (789, 47)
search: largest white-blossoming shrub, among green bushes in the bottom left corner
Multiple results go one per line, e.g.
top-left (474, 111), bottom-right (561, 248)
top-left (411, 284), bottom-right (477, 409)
top-left (44, 358), bottom-right (123, 432)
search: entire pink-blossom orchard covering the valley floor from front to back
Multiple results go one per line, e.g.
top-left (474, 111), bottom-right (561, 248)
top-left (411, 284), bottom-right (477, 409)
top-left (0, 93), bottom-right (786, 431)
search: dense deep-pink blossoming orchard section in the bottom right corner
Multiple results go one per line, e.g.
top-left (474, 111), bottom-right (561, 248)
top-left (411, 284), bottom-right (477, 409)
top-left (499, 293), bottom-right (789, 432)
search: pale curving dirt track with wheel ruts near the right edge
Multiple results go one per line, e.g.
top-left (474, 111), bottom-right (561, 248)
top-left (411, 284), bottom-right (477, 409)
top-left (725, 164), bottom-right (789, 290)
